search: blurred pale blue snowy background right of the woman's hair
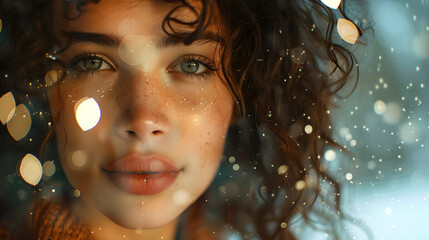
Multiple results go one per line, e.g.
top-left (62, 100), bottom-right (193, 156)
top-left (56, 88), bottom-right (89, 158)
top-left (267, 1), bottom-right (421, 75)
top-left (294, 0), bottom-right (429, 240)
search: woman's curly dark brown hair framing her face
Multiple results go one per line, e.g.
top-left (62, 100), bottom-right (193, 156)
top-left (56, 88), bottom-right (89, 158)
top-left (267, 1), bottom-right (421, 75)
top-left (0, 0), bottom-right (368, 239)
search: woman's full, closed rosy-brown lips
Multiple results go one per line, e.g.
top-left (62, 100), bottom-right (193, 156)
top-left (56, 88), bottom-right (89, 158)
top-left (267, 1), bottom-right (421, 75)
top-left (102, 154), bottom-right (182, 195)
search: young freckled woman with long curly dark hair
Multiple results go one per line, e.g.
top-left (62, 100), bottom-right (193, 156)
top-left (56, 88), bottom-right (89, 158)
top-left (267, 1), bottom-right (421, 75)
top-left (0, 0), bottom-right (366, 240)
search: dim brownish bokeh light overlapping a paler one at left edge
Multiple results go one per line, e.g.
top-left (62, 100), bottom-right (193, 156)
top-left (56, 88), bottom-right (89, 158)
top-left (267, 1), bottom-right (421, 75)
top-left (7, 104), bottom-right (31, 141)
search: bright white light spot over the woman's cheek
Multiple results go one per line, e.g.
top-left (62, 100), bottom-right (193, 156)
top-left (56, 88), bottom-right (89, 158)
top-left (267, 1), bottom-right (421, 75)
top-left (75, 97), bottom-right (101, 131)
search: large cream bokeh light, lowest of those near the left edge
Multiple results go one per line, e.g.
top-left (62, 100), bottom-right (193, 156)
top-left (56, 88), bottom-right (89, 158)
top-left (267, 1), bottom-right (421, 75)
top-left (19, 153), bottom-right (43, 186)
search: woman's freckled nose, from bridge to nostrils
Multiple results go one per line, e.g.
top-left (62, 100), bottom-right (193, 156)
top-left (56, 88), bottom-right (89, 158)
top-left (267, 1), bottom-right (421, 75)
top-left (116, 71), bottom-right (169, 141)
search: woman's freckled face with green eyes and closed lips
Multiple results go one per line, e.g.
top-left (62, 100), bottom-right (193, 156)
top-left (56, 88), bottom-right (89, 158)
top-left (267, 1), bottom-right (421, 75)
top-left (50, 0), bottom-right (233, 231)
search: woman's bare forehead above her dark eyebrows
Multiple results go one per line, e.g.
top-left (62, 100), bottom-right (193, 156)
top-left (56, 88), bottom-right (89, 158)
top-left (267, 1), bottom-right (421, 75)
top-left (61, 0), bottom-right (206, 37)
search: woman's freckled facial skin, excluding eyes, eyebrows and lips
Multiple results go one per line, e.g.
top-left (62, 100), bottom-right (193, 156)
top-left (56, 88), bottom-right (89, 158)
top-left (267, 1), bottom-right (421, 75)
top-left (50, 0), bottom-right (233, 239)
